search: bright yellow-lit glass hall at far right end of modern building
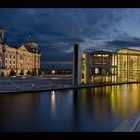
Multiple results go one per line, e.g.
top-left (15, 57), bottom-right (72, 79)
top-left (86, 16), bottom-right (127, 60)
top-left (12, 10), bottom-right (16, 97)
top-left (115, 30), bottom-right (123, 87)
top-left (117, 49), bottom-right (140, 82)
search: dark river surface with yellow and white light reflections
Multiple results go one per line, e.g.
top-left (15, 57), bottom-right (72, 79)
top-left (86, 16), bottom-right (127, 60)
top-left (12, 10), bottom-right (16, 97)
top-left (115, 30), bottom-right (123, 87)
top-left (0, 84), bottom-right (140, 131)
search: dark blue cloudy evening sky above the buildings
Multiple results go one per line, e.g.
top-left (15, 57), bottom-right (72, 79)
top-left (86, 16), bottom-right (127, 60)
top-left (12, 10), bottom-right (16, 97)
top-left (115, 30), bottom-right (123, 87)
top-left (0, 8), bottom-right (140, 68)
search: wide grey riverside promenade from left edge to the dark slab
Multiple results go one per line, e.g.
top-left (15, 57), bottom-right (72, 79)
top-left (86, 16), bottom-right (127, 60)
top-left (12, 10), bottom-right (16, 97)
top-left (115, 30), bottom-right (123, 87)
top-left (0, 77), bottom-right (72, 93)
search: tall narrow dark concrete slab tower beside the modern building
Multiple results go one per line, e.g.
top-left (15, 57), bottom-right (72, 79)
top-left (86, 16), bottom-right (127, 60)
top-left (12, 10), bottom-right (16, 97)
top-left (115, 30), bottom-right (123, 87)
top-left (73, 44), bottom-right (82, 86)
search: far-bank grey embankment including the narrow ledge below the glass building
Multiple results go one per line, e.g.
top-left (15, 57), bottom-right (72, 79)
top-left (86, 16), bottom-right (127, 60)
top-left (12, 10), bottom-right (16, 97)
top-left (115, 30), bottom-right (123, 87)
top-left (0, 78), bottom-right (138, 93)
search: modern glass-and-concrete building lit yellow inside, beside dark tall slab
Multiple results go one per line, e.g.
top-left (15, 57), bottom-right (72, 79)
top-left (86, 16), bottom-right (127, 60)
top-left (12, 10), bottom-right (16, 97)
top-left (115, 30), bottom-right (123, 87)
top-left (75, 44), bottom-right (140, 84)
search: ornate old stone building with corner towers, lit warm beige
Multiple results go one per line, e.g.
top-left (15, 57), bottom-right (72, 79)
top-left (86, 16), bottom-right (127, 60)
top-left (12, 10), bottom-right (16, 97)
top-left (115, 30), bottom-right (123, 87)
top-left (0, 29), bottom-right (40, 76)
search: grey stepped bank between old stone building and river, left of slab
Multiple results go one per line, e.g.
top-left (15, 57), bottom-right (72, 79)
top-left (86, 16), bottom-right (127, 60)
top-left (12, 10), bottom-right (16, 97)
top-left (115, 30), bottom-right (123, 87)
top-left (0, 78), bottom-right (72, 92)
